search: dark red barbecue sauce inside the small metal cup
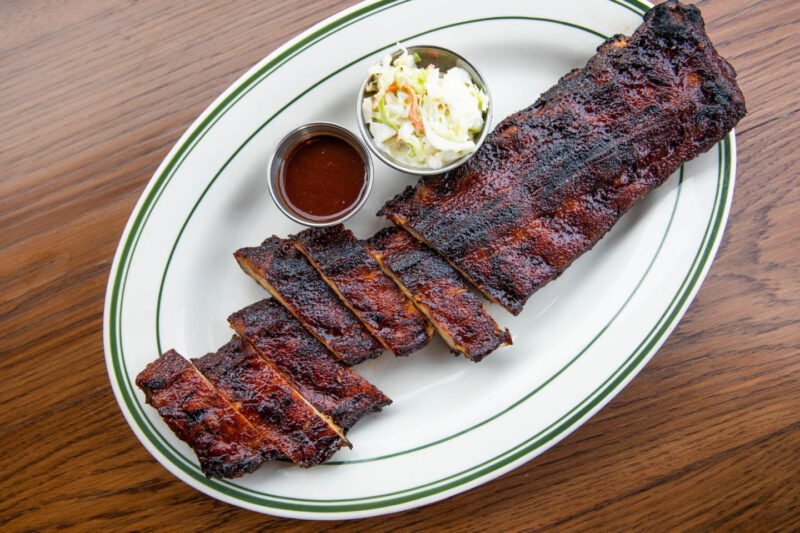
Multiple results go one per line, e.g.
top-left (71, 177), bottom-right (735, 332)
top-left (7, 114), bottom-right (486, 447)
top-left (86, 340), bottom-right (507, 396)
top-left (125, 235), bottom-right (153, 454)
top-left (278, 134), bottom-right (367, 222)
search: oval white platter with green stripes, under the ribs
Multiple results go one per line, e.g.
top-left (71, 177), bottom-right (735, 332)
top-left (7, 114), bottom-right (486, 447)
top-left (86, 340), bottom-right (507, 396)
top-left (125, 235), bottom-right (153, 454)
top-left (104, 0), bottom-right (736, 519)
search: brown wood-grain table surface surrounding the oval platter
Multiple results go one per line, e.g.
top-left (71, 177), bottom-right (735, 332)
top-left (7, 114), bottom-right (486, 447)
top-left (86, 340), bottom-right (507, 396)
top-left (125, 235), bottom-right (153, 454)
top-left (0, 0), bottom-right (800, 531)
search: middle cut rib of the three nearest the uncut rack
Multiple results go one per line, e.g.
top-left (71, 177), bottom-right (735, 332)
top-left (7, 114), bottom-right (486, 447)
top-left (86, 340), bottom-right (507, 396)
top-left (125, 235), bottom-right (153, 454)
top-left (292, 224), bottom-right (433, 355)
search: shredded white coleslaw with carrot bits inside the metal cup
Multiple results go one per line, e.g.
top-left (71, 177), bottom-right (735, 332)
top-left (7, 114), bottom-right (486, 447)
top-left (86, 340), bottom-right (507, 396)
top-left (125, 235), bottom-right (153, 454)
top-left (361, 49), bottom-right (489, 169)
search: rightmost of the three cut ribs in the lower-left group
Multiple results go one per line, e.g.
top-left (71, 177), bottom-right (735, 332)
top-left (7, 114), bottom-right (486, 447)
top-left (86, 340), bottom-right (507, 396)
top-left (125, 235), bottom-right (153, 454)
top-left (228, 298), bottom-right (392, 430)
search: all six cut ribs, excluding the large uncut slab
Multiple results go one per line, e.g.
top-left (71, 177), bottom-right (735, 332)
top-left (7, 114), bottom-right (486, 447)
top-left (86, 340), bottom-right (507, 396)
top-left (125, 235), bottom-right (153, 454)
top-left (136, 225), bottom-right (511, 478)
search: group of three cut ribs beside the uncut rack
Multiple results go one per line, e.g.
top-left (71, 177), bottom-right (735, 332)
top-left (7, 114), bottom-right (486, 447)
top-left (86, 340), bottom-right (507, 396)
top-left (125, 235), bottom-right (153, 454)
top-left (234, 224), bottom-right (511, 365)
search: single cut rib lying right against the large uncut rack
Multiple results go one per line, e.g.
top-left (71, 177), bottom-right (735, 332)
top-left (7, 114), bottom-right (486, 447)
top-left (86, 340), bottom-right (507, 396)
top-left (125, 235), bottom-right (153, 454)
top-left (366, 228), bottom-right (511, 361)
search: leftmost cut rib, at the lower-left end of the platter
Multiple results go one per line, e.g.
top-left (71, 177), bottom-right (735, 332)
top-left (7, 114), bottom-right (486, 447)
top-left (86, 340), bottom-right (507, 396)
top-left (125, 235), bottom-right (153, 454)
top-left (136, 350), bottom-right (278, 478)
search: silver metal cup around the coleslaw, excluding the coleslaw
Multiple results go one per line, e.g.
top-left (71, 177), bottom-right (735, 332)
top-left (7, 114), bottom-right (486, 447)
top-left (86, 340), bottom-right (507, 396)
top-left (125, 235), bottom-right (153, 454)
top-left (356, 45), bottom-right (492, 175)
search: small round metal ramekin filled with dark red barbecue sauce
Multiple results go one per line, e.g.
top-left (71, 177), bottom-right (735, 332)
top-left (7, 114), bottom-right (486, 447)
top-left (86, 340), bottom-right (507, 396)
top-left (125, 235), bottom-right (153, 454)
top-left (268, 122), bottom-right (372, 226)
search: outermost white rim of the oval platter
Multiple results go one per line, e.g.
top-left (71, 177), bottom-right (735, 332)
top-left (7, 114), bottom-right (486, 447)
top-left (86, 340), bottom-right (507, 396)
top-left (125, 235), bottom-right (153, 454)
top-left (103, 0), bottom-right (736, 519)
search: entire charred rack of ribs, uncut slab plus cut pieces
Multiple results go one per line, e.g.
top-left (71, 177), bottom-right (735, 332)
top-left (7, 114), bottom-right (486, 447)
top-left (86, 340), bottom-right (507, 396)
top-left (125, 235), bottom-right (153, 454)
top-left (136, 0), bottom-right (745, 477)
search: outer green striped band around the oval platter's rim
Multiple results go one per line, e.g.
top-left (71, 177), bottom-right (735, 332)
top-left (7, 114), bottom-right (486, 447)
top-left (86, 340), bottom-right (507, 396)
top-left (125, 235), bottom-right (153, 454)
top-left (107, 0), bottom-right (734, 512)
